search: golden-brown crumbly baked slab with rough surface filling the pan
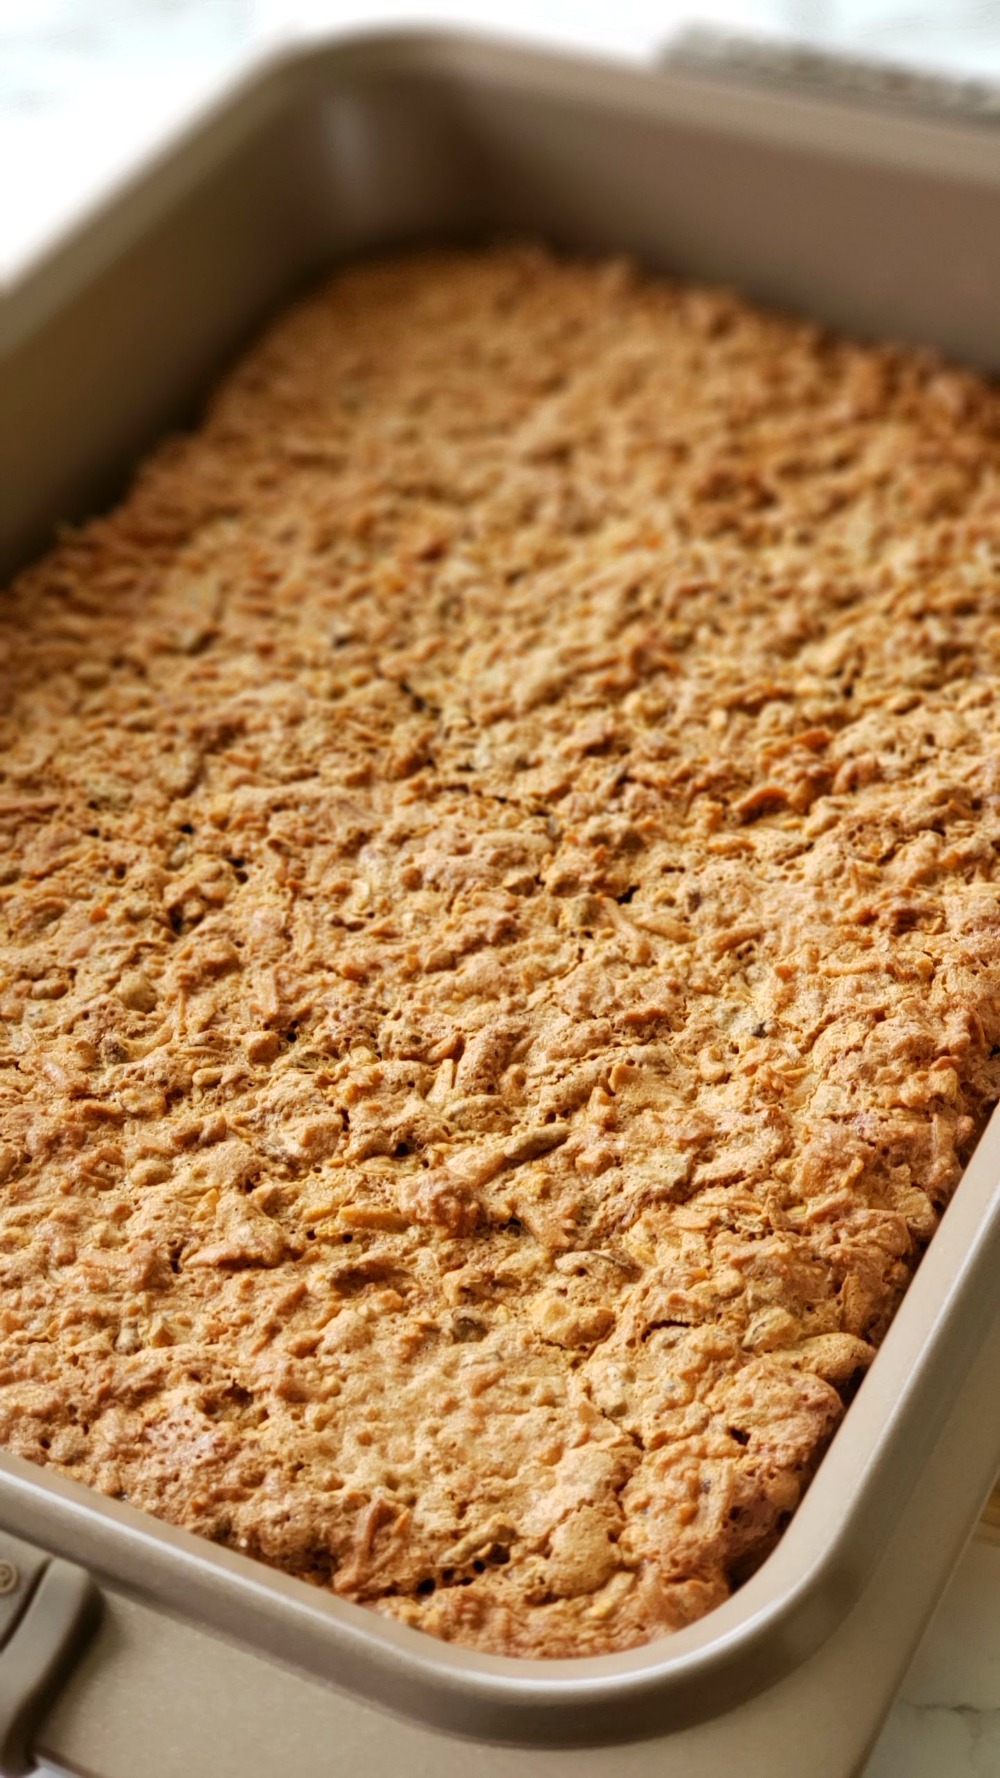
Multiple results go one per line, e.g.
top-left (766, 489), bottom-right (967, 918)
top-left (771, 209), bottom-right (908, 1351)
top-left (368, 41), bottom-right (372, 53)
top-left (0, 249), bottom-right (1000, 1655)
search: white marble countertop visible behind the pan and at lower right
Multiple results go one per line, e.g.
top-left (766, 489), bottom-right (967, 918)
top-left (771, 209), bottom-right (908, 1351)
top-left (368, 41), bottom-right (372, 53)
top-left (0, 0), bottom-right (1000, 1778)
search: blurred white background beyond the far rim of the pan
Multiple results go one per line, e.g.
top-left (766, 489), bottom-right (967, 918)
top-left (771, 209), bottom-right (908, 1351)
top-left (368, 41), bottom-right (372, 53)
top-left (0, 0), bottom-right (1000, 277)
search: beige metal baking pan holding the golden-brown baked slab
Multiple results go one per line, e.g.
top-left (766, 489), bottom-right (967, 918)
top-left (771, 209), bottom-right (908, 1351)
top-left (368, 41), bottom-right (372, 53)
top-left (0, 34), bottom-right (1000, 1778)
